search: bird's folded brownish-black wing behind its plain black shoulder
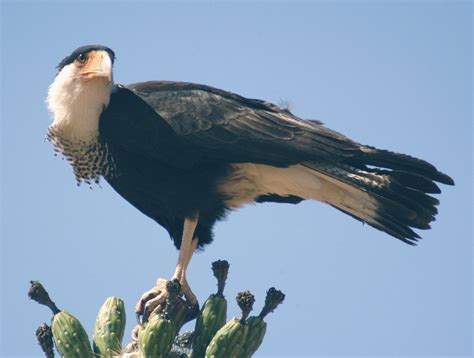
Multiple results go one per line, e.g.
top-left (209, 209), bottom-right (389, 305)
top-left (123, 81), bottom-right (359, 166)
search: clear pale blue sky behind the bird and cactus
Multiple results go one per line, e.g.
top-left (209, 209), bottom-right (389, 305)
top-left (0, 1), bottom-right (473, 357)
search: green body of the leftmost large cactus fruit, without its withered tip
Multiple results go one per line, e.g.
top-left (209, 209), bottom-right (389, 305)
top-left (51, 311), bottom-right (94, 358)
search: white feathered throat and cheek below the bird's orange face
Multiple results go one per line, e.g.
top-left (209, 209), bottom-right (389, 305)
top-left (46, 64), bottom-right (113, 143)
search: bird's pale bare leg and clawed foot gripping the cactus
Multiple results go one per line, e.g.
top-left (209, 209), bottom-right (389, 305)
top-left (135, 215), bottom-right (198, 321)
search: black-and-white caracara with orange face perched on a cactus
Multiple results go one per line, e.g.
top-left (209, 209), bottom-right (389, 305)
top-left (46, 45), bottom-right (454, 314)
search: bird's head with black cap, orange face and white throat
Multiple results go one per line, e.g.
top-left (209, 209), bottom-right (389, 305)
top-left (46, 45), bottom-right (115, 141)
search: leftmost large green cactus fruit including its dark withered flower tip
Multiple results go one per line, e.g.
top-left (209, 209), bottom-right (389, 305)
top-left (28, 281), bottom-right (94, 358)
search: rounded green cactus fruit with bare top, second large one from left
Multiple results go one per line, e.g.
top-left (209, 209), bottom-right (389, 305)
top-left (93, 297), bottom-right (125, 358)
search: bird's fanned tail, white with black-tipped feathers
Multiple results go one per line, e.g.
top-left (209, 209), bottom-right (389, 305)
top-left (302, 147), bottom-right (454, 245)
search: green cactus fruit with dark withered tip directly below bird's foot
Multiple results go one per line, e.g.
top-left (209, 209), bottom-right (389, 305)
top-left (138, 280), bottom-right (181, 358)
